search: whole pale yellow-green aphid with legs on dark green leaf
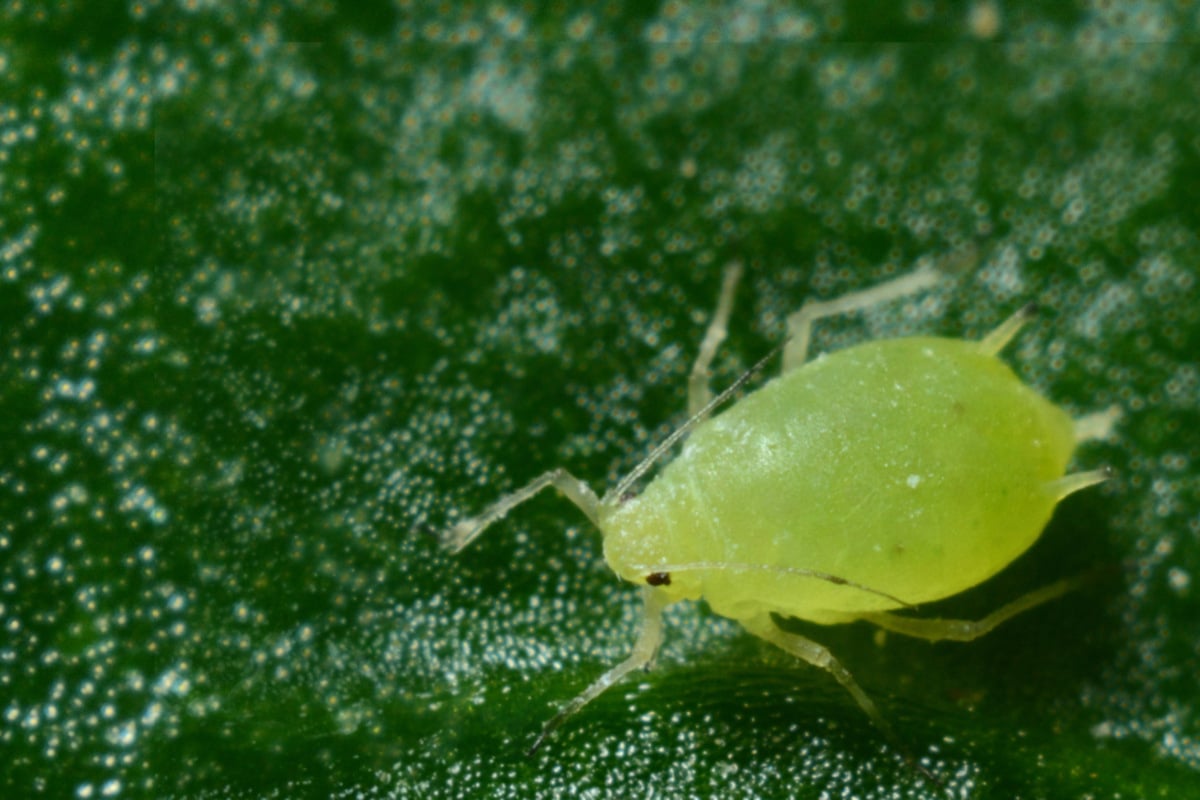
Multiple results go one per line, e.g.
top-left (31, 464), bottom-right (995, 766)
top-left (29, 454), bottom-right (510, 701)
top-left (444, 265), bottom-right (1118, 762)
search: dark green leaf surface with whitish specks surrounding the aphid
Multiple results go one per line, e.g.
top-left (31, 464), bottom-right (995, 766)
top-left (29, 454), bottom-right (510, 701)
top-left (0, 0), bottom-right (1200, 800)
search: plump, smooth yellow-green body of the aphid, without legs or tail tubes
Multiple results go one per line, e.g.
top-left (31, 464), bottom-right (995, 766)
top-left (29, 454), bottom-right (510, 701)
top-left (606, 338), bottom-right (1074, 621)
